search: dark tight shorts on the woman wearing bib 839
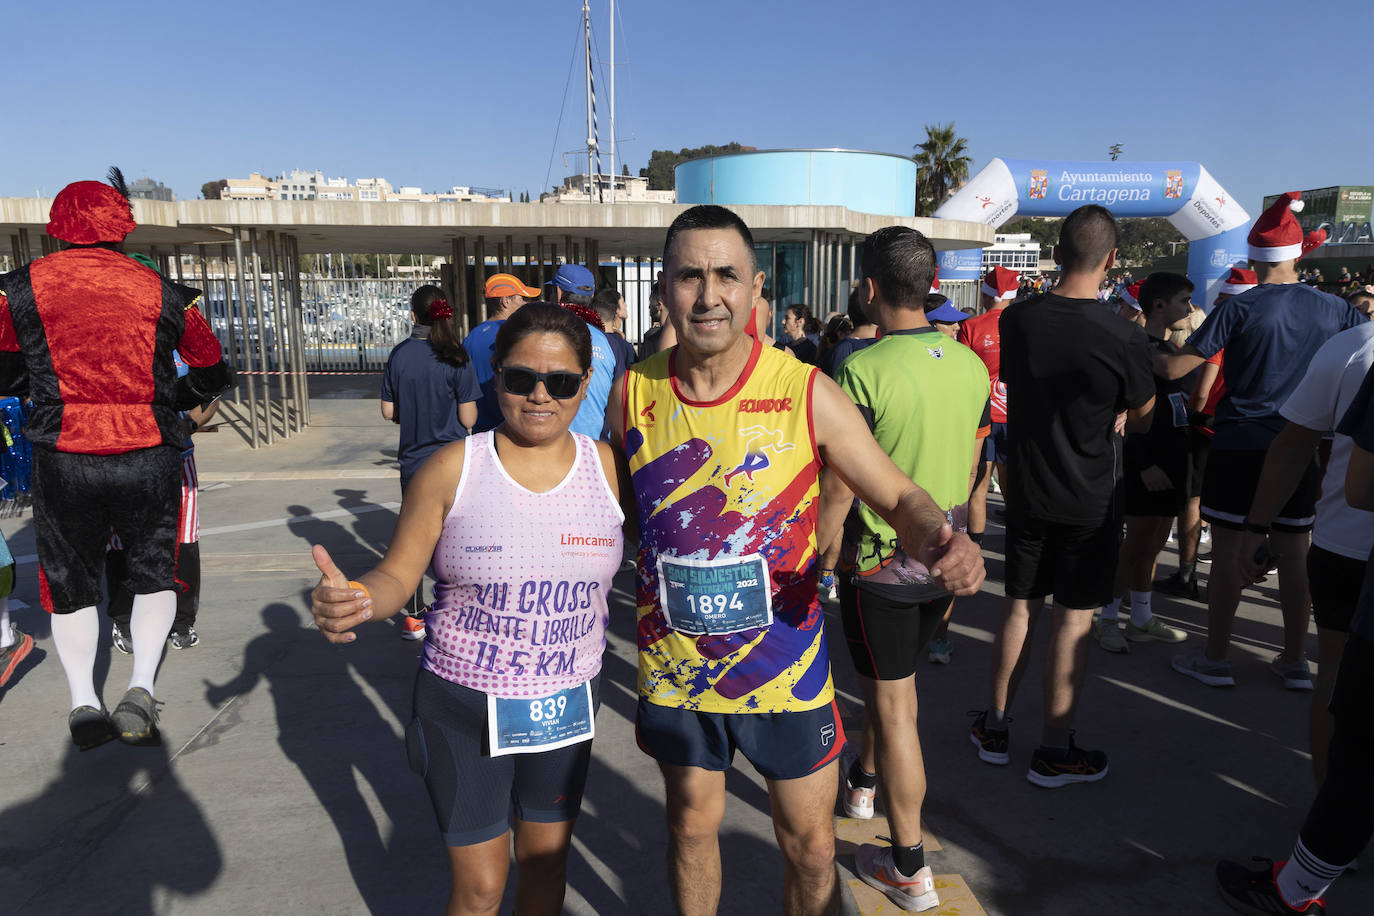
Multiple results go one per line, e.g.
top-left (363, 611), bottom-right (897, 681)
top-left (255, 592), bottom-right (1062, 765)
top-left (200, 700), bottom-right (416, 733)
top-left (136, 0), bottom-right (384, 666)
top-left (405, 669), bottom-right (600, 846)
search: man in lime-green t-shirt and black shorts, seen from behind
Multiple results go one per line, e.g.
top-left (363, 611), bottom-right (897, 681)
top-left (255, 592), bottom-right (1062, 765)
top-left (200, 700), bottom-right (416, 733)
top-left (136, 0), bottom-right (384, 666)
top-left (820, 225), bottom-right (992, 911)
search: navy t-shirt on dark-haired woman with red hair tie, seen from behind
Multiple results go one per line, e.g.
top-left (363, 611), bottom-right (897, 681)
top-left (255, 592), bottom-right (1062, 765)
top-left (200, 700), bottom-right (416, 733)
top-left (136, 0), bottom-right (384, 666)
top-left (382, 328), bottom-right (482, 483)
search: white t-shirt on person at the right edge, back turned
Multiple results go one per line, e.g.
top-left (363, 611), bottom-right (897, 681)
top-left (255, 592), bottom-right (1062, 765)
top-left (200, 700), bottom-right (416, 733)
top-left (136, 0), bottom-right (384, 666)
top-left (1279, 323), bottom-right (1374, 560)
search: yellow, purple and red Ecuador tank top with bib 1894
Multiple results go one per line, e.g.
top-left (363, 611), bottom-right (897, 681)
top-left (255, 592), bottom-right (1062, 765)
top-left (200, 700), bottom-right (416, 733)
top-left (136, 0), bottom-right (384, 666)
top-left (621, 341), bottom-right (834, 713)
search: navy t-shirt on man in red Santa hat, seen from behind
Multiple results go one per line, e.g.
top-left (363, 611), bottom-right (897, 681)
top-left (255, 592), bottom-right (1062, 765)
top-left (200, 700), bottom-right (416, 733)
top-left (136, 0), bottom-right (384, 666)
top-left (1189, 283), bottom-right (1369, 450)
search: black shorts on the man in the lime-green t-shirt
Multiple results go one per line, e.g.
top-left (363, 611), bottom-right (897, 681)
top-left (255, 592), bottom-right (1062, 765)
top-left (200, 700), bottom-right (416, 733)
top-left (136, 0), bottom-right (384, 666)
top-left (840, 580), bottom-right (954, 681)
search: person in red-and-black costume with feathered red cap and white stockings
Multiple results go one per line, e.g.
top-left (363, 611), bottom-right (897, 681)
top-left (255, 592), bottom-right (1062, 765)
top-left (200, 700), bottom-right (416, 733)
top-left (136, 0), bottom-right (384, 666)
top-left (0, 169), bottom-right (228, 750)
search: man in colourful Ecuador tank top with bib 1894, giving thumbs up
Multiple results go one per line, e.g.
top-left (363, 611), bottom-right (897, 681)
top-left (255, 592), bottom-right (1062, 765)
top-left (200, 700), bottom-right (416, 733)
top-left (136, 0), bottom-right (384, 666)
top-left (611, 206), bottom-right (984, 915)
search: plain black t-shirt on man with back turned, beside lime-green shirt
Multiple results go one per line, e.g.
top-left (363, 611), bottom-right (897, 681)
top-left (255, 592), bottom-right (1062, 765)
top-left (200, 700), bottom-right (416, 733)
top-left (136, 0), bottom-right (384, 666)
top-left (1000, 293), bottom-right (1154, 526)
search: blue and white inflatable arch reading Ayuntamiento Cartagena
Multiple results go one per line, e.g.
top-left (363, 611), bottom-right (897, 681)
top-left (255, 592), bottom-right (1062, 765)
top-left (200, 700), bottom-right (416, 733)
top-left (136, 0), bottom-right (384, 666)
top-left (936, 159), bottom-right (1250, 309)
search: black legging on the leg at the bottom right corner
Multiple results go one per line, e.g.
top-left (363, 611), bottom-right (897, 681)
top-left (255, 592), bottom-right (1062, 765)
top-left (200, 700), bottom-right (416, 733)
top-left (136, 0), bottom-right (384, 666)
top-left (1301, 633), bottom-right (1374, 865)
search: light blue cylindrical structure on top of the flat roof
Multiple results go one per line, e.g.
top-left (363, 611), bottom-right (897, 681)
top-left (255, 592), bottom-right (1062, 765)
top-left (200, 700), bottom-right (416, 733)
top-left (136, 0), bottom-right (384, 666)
top-left (675, 150), bottom-right (916, 217)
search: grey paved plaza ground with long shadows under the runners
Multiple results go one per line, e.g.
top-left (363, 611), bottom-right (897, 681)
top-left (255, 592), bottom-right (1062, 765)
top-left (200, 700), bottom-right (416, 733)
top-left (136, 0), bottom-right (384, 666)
top-left (0, 390), bottom-right (1374, 916)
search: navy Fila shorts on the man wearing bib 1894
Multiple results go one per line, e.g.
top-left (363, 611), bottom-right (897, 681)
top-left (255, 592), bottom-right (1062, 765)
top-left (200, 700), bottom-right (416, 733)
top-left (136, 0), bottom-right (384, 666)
top-left (635, 696), bottom-right (845, 779)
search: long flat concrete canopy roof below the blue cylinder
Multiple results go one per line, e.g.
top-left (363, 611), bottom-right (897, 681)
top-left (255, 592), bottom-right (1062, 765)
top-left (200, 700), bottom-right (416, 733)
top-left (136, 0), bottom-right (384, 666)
top-left (0, 198), bottom-right (993, 258)
